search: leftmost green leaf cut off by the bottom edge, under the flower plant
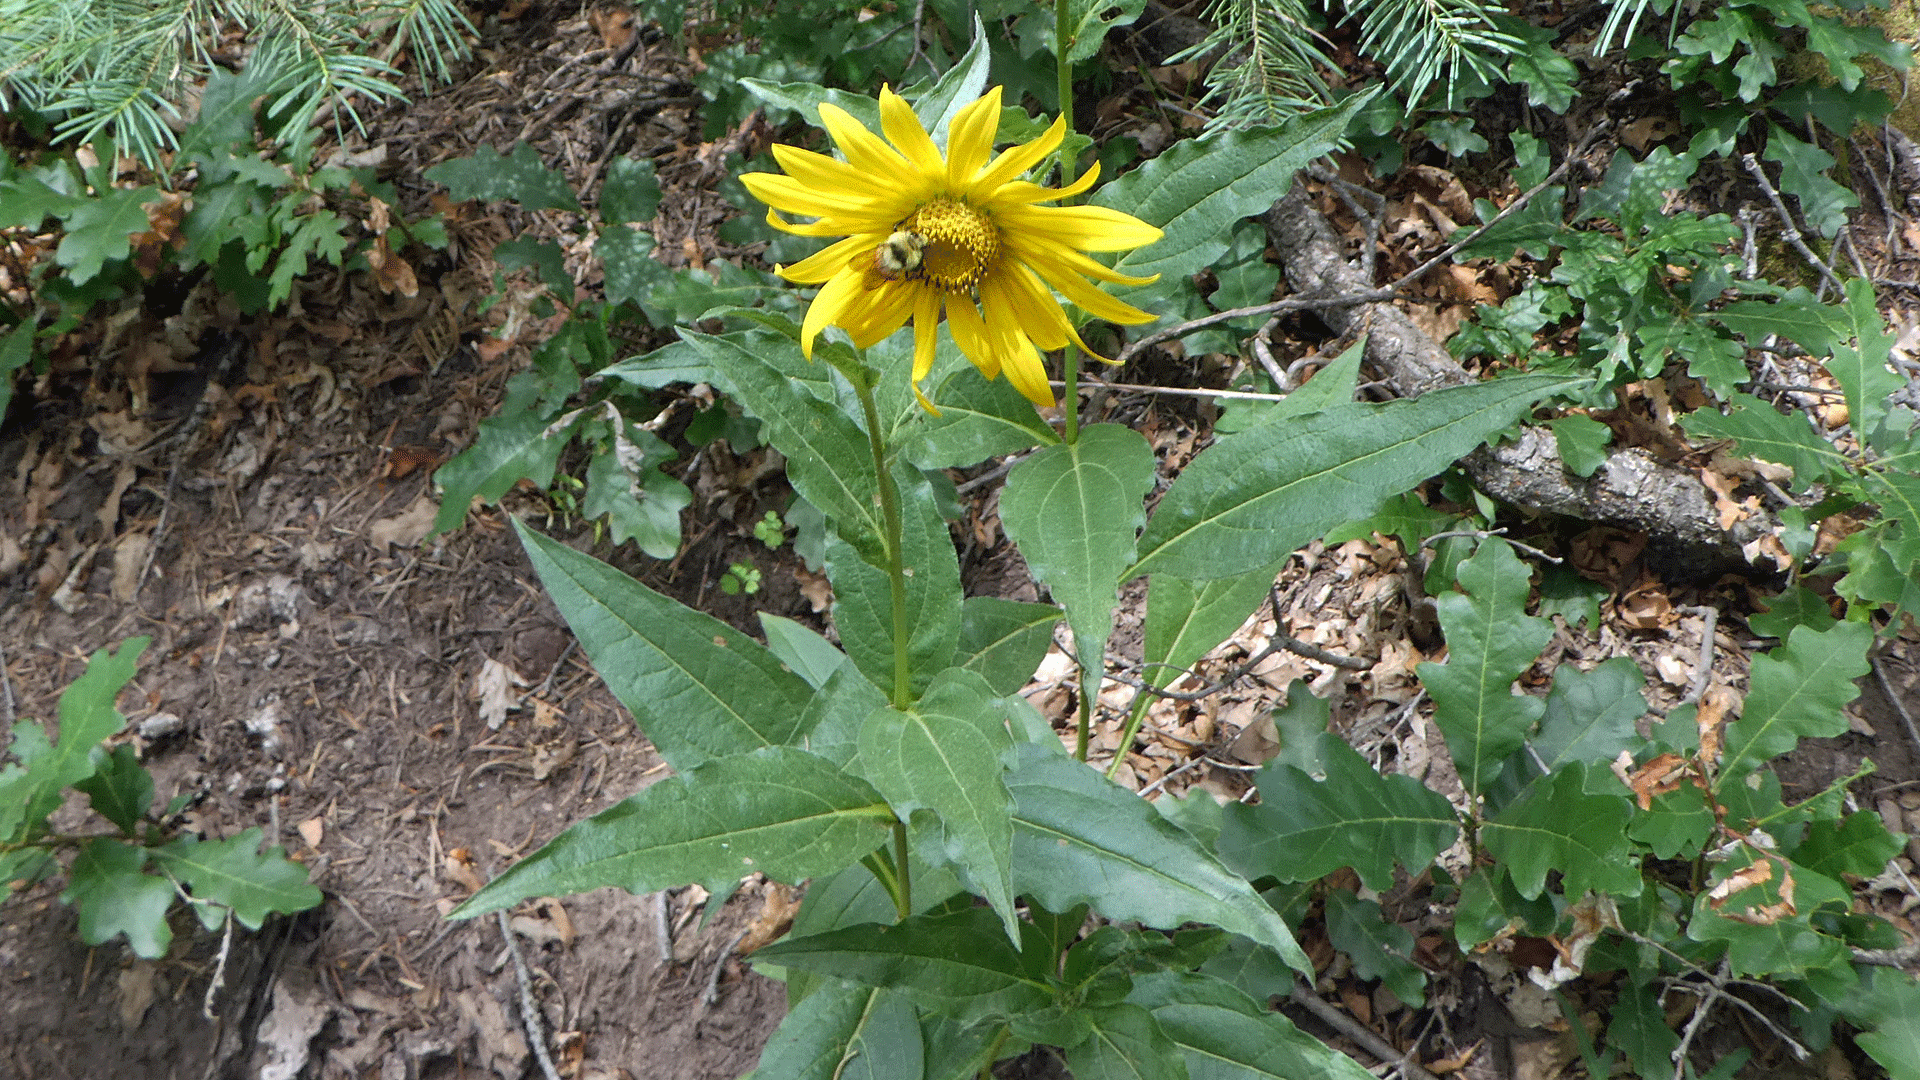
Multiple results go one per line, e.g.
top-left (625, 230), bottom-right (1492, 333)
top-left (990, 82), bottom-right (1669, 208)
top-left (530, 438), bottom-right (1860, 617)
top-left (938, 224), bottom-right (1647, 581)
top-left (753, 982), bottom-right (925, 1080)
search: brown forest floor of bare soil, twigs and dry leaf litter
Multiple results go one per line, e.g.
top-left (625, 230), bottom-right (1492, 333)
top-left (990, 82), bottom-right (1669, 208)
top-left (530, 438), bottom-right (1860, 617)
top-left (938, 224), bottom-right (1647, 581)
top-left (11, 4), bottom-right (1920, 1080)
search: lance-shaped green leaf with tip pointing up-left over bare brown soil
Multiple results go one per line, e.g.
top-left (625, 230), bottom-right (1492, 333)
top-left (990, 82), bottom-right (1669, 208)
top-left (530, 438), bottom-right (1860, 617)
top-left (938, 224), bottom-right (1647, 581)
top-left (515, 519), bottom-right (812, 773)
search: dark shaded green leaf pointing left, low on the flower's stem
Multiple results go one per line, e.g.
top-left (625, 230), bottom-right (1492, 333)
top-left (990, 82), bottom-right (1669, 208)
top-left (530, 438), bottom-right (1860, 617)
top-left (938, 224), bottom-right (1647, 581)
top-left (755, 907), bottom-right (1054, 1020)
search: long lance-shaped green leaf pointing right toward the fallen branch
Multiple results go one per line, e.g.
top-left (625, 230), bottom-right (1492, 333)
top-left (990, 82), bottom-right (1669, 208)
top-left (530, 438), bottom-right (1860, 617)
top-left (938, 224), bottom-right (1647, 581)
top-left (1121, 375), bottom-right (1580, 580)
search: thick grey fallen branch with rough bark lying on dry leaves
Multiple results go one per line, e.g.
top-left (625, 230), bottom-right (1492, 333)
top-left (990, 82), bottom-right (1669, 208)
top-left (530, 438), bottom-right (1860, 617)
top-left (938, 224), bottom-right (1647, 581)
top-left (1261, 183), bottom-right (1766, 573)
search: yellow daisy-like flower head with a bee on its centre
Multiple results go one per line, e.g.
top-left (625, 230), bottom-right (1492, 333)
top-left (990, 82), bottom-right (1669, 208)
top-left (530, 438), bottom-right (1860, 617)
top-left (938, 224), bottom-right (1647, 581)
top-left (741, 86), bottom-right (1160, 409)
